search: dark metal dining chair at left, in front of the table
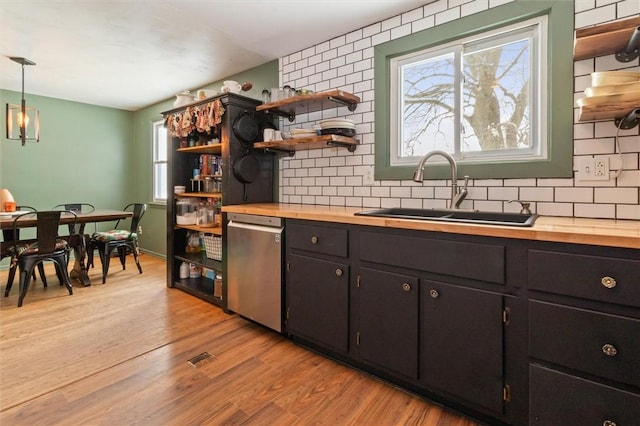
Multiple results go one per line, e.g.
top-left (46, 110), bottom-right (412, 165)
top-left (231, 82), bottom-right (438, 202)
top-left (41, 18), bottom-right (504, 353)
top-left (5, 210), bottom-right (77, 307)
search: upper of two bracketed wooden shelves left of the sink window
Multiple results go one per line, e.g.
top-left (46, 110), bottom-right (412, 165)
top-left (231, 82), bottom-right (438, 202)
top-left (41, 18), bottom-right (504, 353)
top-left (256, 90), bottom-right (360, 121)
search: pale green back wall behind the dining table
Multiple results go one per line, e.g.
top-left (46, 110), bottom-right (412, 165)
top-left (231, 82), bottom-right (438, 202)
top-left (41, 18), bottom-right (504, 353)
top-left (0, 90), bottom-right (135, 266)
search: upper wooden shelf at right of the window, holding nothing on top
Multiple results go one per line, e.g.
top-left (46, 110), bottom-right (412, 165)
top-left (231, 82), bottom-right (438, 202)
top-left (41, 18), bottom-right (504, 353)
top-left (573, 17), bottom-right (640, 61)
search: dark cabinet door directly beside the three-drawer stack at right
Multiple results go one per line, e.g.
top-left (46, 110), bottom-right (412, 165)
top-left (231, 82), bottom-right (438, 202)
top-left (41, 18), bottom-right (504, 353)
top-left (420, 281), bottom-right (504, 413)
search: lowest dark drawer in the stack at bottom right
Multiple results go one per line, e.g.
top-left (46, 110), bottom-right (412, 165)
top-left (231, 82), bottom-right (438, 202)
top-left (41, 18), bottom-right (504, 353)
top-left (529, 365), bottom-right (640, 426)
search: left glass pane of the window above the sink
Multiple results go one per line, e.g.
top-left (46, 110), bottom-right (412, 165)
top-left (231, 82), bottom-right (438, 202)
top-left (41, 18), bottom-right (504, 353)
top-left (398, 53), bottom-right (456, 157)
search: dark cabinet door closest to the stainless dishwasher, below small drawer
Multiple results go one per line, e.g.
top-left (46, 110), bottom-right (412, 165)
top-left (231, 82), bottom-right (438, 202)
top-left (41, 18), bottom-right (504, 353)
top-left (285, 254), bottom-right (349, 352)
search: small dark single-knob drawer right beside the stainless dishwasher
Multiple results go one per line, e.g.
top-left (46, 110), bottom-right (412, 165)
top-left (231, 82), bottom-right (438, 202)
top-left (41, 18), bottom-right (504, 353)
top-left (287, 224), bottom-right (349, 257)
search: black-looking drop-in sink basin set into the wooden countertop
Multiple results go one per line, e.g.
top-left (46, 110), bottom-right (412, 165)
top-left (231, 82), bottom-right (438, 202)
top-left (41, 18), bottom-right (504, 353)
top-left (355, 207), bottom-right (538, 226)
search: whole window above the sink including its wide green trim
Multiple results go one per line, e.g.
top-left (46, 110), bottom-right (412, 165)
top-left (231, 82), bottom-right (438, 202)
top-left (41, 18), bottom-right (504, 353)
top-left (375, 1), bottom-right (573, 179)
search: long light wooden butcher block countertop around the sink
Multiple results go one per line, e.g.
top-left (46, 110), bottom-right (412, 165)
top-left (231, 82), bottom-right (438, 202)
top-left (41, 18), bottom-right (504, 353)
top-left (222, 203), bottom-right (640, 249)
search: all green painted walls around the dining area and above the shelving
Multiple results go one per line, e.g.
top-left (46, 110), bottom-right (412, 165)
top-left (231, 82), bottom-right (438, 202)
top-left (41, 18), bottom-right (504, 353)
top-left (0, 60), bottom-right (278, 267)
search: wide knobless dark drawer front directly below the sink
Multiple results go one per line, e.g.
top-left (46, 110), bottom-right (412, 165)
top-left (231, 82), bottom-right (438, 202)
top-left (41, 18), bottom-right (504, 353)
top-left (360, 232), bottom-right (505, 284)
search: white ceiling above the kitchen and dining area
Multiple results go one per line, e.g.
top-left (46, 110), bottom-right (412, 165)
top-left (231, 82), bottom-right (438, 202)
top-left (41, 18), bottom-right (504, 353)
top-left (0, 0), bottom-right (434, 110)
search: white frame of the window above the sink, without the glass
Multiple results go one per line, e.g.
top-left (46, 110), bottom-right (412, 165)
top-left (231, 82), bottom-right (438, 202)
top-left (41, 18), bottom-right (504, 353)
top-left (389, 15), bottom-right (549, 166)
